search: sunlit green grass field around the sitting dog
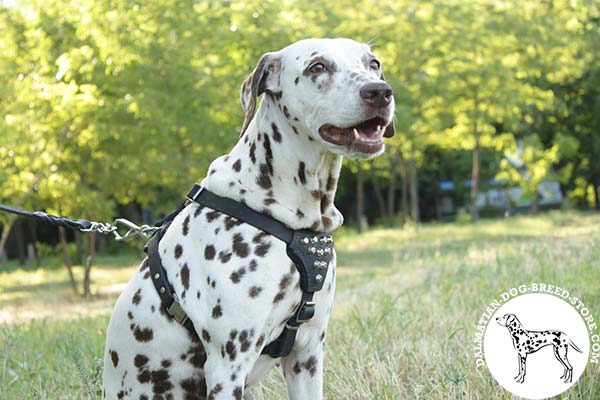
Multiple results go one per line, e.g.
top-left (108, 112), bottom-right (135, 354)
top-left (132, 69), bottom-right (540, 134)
top-left (0, 212), bottom-right (600, 400)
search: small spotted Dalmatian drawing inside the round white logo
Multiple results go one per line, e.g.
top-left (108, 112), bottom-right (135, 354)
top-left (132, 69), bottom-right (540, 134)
top-left (496, 314), bottom-right (582, 383)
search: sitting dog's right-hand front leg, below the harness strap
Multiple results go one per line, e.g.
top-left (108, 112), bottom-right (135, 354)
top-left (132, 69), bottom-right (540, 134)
top-left (281, 343), bottom-right (324, 400)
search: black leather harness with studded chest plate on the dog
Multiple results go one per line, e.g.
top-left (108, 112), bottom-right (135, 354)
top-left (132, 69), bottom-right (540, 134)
top-left (145, 184), bottom-right (333, 358)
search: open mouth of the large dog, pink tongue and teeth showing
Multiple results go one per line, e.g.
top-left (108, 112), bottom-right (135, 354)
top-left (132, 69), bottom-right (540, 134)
top-left (319, 117), bottom-right (387, 154)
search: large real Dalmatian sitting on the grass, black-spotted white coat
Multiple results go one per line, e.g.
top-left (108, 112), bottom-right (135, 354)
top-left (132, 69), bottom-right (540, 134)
top-left (103, 39), bottom-right (394, 400)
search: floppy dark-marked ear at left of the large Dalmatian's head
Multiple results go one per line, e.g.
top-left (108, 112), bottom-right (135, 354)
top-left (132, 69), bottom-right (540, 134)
top-left (240, 53), bottom-right (280, 137)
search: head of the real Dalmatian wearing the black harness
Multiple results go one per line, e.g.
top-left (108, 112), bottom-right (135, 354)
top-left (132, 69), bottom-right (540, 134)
top-left (241, 39), bottom-right (395, 158)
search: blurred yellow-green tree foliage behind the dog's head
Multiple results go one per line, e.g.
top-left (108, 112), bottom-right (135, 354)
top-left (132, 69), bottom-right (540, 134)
top-left (0, 0), bottom-right (600, 223)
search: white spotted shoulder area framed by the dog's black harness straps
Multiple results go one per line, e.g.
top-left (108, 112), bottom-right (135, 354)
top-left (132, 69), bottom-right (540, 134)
top-left (159, 204), bottom-right (325, 345)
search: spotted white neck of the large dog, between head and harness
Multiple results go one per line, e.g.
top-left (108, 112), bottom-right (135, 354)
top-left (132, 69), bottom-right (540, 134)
top-left (202, 96), bottom-right (343, 231)
